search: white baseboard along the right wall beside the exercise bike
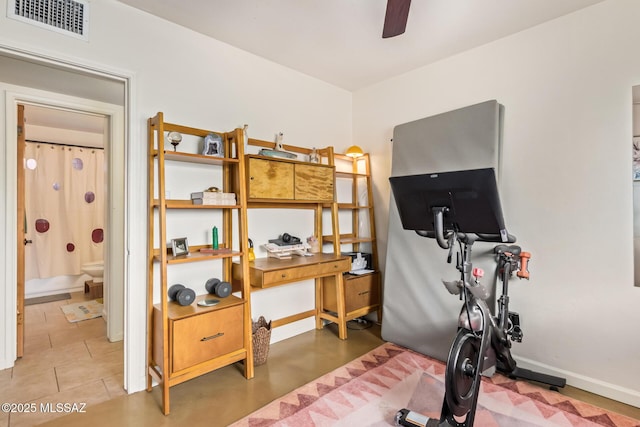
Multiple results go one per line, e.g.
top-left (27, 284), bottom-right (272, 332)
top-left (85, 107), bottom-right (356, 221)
top-left (515, 357), bottom-right (640, 408)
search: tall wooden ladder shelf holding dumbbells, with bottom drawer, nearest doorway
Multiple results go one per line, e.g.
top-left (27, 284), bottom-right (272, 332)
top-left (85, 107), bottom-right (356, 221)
top-left (147, 113), bottom-right (253, 415)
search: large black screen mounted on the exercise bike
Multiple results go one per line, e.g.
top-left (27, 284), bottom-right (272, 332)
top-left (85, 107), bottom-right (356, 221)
top-left (389, 168), bottom-right (506, 234)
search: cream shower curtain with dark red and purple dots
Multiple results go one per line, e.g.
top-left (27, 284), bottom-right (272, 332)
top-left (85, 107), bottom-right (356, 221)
top-left (25, 142), bottom-right (105, 280)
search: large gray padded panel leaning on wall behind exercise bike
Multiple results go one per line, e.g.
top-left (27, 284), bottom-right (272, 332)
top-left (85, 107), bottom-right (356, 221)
top-left (382, 100), bottom-right (502, 361)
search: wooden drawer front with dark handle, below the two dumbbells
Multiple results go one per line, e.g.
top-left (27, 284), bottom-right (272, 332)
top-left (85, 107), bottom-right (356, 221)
top-left (170, 305), bottom-right (244, 372)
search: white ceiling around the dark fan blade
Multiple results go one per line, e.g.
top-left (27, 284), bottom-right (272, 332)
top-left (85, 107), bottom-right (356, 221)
top-left (119, 0), bottom-right (603, 91)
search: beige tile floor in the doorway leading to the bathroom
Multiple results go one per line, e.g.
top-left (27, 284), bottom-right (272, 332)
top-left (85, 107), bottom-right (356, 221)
top-left (0, 292), bottom-right (126, 427)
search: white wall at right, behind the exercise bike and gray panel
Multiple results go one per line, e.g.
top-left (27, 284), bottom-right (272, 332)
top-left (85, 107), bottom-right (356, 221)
top-left (353, 0), bottom-right (640, 406)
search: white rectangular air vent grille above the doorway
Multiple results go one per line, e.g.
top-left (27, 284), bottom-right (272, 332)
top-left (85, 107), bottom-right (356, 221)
top-left (7, 0), bottom-right (89, 40)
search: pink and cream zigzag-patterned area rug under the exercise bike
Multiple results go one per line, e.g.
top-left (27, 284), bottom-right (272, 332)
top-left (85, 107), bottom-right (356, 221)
top-left (232, 343), bottom-right (640, 427)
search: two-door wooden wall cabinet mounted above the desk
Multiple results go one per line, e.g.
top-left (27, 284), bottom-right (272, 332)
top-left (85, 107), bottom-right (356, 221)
top-left (247, 155), bottom-right (335, 203)
